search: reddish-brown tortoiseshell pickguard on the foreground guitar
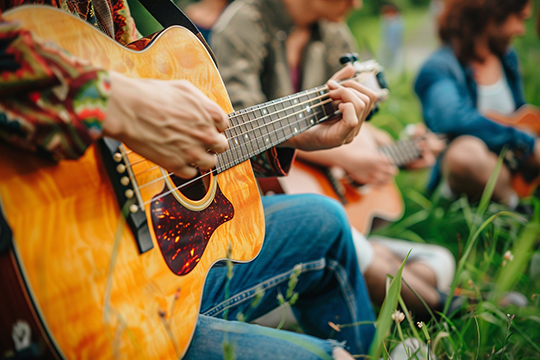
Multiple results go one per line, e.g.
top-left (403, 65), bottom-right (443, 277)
top-left (150, 184), bottom-right (234, 275)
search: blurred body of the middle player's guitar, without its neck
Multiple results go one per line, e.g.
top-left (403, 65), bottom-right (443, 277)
top-left (279, 160), bottom-right (404, 235)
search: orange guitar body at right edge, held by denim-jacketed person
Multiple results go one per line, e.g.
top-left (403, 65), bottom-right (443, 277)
top-left (488, 106), bottom-right (540, 198)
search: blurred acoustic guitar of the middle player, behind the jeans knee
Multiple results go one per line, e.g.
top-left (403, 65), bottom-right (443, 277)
top-left (279, 139), bottom-right (434, 234)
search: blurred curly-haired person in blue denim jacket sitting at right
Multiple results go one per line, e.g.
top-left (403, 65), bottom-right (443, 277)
top-left (414, 0), bottom-right (540, 208)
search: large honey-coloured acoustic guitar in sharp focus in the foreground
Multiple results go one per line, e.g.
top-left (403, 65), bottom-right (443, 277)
top-left (0, 6), bottom-right (384, 360)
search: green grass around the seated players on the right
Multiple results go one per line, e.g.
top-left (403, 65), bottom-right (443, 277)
top-left (349, 4), bottom-right (540, 359)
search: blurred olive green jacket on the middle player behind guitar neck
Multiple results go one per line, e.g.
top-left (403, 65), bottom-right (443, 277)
top-left (211, 0), bottom-right (357, 110)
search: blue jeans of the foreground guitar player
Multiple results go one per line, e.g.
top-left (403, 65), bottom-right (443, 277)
top-left (184, 195), bottom-right (375, 360)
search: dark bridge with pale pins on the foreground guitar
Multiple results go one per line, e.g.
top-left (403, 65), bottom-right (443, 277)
top-left (98, 138), bottom-right (154, 254)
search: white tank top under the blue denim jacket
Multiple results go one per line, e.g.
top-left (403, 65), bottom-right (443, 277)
top-left (477, 74), bottom-right (516, 115)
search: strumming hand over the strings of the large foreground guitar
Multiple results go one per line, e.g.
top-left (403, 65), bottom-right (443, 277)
top-left (103, 72), bottom-right (229, 178)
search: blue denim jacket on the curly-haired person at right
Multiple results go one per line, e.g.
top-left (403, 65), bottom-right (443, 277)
top-left (414, 46), bottom-right (535, 190)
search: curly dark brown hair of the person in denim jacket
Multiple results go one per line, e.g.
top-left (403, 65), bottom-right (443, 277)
top-left (439, 0), bottom-right (530, 64)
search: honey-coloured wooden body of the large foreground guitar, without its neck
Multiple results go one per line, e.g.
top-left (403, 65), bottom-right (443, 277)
top-left (0, 6), bottom-right (264, 359)
